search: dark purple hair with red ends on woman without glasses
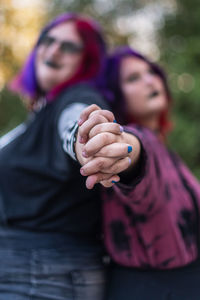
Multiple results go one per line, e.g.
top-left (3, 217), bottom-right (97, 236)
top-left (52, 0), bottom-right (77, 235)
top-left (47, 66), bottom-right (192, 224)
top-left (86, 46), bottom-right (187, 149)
top-left (105, 46), bottom-right (172, 135)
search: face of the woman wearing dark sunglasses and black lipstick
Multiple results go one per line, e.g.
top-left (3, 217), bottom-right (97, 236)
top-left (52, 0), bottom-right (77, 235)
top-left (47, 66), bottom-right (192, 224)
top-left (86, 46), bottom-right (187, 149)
top-left (36, 21), bottom-right (83, 92)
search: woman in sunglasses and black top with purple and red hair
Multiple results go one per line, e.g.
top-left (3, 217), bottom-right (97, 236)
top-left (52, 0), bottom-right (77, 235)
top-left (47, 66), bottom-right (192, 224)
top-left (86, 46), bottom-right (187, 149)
top-left (0, 14), bottom-right (133, 300)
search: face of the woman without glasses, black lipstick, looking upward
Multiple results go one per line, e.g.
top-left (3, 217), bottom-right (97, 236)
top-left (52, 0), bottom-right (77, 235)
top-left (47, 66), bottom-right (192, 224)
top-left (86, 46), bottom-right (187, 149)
top-left (120, 56), bottom-right (167, 121)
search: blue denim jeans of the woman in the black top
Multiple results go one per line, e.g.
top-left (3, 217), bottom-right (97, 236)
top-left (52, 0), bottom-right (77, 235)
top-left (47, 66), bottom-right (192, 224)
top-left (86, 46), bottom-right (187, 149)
top-left (0, 230), bottom-right (106, 300)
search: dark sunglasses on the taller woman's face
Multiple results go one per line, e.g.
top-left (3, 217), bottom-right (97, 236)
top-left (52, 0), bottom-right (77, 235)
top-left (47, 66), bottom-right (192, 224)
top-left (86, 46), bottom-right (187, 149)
top-left (39, 35), bottom-right (83, 54)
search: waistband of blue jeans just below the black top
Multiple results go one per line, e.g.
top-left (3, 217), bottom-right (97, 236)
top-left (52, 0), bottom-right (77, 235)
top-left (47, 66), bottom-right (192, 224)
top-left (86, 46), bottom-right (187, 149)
top-left (0, 226), bottom-right (103, 252)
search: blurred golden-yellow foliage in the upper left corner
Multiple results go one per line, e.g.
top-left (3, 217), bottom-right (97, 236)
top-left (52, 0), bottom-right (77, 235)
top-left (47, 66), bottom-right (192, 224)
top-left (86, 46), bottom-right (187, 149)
top-left (0, 0), bottom-right (44, 88)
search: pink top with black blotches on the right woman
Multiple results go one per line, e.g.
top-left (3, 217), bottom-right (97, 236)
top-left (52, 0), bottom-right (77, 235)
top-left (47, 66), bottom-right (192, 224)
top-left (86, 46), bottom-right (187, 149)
top-left (104, 126), bottom-right (200, 269)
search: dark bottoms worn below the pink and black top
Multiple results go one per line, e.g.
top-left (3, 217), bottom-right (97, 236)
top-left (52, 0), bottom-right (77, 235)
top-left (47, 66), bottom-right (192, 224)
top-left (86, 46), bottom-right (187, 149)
top-left (105, 261), bottom-right (200, 300)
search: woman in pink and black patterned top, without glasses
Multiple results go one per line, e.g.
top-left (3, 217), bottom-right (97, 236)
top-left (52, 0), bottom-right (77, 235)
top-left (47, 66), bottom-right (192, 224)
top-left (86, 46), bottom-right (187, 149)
top-left (77, 47), bottom-right (200, 300)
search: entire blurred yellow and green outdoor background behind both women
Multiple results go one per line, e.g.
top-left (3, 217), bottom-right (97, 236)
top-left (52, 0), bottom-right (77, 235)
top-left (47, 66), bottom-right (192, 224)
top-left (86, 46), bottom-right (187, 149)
top-left (0, 0), bottom-right (200, 179)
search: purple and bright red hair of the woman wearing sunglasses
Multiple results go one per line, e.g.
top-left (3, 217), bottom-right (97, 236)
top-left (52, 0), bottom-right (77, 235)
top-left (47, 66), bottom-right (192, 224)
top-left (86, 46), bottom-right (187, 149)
top-left (9, 13), bottom-right (106, 102)
